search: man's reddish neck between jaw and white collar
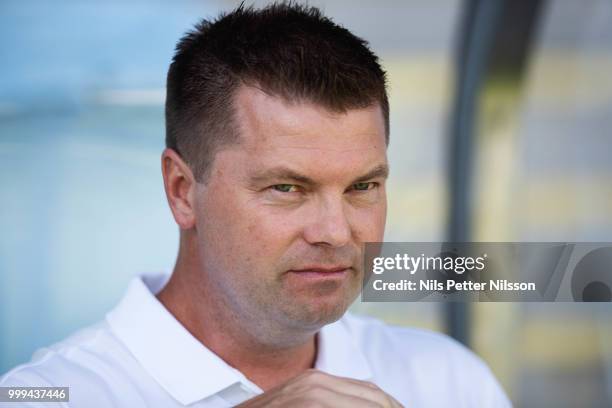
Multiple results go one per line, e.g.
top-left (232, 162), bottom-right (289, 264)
top-left (157, 234), bottom-right (317, 391)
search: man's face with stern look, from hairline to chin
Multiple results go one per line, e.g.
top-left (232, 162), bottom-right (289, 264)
top-left (195, 87), bottom-right (387, 338)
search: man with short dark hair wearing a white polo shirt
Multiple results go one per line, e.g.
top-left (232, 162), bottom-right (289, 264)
top-left (1, 4), bottom-right (509, 407)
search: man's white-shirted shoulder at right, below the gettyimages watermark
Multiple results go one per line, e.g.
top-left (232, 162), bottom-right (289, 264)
top-left (341, 313), bottom-right (510, 407)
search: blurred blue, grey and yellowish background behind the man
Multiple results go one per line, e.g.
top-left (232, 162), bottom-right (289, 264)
top-left (0, 0), bottom-right (612, 407)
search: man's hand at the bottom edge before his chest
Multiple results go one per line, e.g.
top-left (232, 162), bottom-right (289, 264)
top-left (236, 370), bottom-right (403, 408)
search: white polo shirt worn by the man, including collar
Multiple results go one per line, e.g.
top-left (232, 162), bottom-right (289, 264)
top-left (0, 275), bottom-right (511, 408)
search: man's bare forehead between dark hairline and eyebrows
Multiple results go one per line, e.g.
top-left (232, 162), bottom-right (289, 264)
top-left (234, 86), bottom-right (386, 156)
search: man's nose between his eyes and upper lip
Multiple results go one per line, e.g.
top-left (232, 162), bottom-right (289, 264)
top-left (304, 193), bottom-right (352, 248)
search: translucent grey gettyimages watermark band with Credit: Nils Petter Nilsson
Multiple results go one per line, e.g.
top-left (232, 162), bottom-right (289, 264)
top-left (362, 242), bottom-right (612, 302)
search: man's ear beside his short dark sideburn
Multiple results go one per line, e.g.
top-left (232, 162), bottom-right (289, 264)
top-left (161, 149), bottom-right (196, 229)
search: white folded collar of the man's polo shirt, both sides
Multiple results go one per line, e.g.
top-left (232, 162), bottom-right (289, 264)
top-left (106, 274), bottom-right (372, 405)
